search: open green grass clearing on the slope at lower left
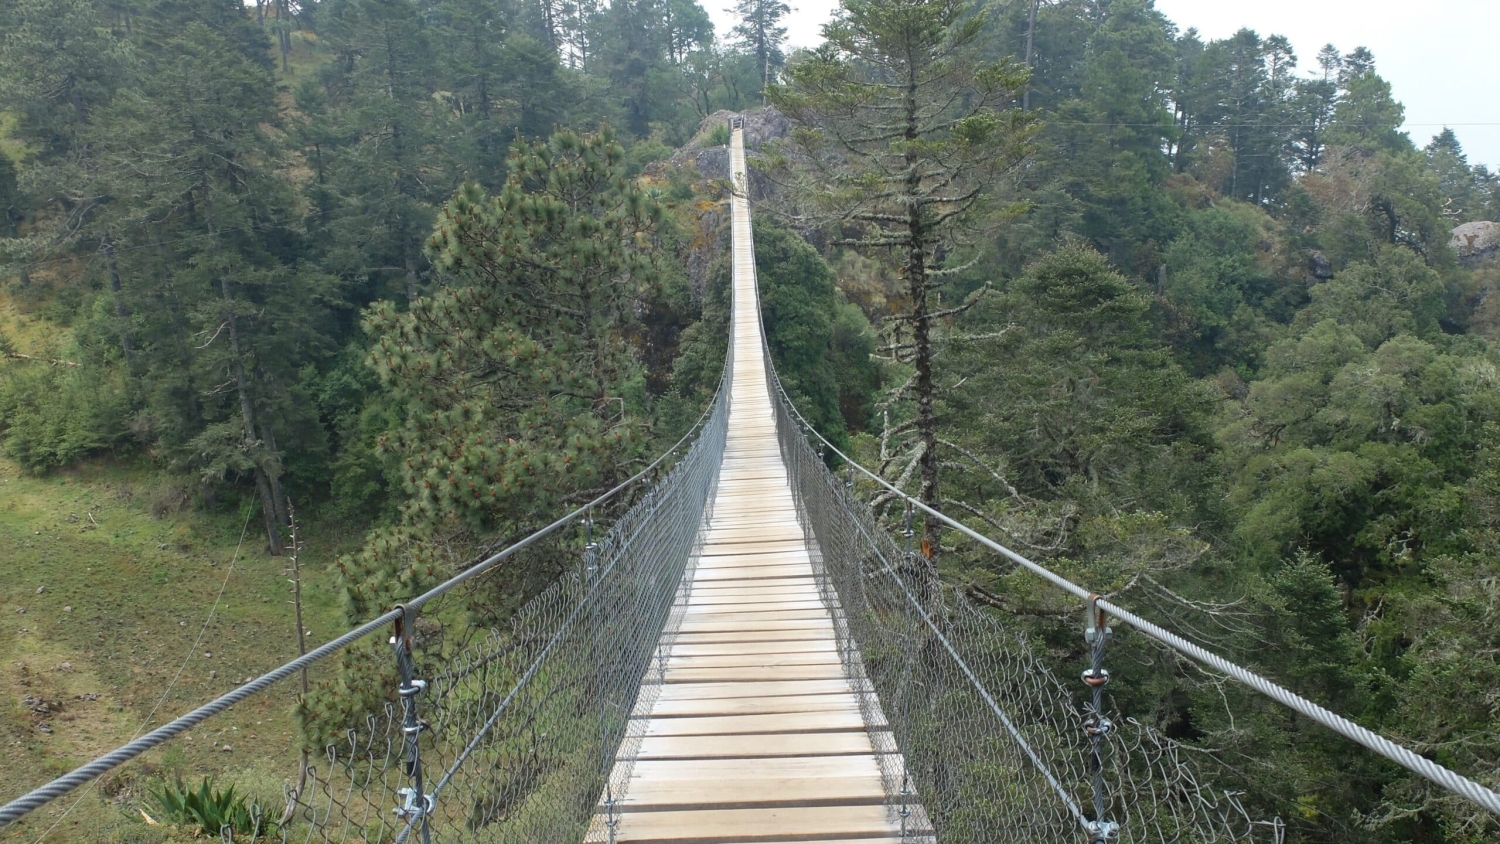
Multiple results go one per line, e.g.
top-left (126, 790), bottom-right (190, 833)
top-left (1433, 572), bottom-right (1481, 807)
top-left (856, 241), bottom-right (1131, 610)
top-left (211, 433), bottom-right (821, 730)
top-left (0, 460), bottom-right (351, 843)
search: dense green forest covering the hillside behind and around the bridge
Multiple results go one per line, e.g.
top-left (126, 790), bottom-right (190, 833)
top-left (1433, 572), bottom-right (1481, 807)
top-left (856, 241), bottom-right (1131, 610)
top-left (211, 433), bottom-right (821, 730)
top-left (0, 0), bottom-right (1500, 844)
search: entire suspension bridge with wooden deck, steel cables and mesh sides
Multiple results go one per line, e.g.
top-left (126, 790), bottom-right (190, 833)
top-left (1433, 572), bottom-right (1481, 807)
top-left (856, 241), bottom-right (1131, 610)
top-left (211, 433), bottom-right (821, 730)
top-left (0, 120), bottom-right (1500, 844)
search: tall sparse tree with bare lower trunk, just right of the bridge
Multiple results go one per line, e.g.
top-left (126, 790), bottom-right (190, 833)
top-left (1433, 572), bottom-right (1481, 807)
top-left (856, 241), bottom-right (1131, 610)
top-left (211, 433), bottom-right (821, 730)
top-left (768, 0), bottom-right (1035, 555)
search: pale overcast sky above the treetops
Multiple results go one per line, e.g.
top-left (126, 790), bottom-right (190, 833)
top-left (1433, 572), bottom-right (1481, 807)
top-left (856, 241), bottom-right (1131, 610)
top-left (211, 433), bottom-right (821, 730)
top-left (701, 0), bottom-right (1500, 166)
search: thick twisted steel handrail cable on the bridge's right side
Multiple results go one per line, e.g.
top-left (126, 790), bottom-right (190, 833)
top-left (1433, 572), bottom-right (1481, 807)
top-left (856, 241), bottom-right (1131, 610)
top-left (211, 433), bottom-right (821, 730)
top-left (771, 361), bottom-right (1500, 816)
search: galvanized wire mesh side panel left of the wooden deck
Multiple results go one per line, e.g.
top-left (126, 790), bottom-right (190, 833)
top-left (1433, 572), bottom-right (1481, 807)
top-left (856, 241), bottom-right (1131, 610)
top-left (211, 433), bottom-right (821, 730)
top-left (278, 391), bottom-right (728, 844)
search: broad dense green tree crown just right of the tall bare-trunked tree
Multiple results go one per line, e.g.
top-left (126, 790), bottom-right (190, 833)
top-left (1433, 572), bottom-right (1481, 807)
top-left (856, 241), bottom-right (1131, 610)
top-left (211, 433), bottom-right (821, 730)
top-left (942, 244), bottom-right (1214, 574)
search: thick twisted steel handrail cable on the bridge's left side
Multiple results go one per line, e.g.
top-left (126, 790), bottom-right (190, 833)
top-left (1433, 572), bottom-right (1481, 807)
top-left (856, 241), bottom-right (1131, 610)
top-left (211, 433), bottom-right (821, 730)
top-left (0, 357), bottom-right (732, 826)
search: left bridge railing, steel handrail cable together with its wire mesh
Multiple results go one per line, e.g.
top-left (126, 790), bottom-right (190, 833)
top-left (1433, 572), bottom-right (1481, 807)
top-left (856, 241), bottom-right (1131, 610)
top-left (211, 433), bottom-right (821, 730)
top-left (0, 356), bottom-right (734, 844)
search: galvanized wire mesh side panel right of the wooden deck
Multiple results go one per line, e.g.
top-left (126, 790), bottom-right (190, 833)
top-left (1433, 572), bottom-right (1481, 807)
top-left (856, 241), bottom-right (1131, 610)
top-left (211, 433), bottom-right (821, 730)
top-left (776, 352), bottom-right (1283, 844)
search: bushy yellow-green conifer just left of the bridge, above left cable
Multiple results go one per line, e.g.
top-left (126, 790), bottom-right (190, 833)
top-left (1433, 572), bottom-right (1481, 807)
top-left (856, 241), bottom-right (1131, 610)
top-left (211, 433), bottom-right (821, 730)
top-left (347, 129), bottom-right (662, 609)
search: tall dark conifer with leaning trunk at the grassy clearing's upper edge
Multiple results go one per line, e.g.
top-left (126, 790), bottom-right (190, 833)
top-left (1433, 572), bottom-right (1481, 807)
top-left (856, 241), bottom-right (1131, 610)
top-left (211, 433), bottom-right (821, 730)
top-left (83, 15), bottom-right (333, 553)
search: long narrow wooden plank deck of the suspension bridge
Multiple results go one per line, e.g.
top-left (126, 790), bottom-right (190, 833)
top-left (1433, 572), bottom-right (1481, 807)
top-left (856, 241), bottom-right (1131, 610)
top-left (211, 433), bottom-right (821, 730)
top-left (591, 129), bottom-right (900, 844)
